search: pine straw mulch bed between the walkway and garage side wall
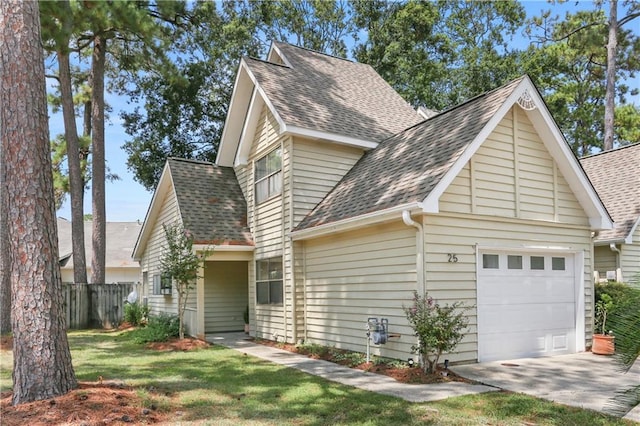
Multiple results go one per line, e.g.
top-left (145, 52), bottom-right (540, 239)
top-left (253, 339), bottom-right (475, 384)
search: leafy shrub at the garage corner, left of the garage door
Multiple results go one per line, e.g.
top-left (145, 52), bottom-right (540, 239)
top-left (403, 292), bottom-right (469, 373)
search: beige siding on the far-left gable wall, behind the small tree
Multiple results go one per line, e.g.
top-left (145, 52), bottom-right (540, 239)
top-left (140, 187), bottom-right (181, 314)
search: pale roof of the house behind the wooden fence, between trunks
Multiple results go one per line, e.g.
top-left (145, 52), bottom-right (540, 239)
top-left (58, 218), bottom-right (142, 269)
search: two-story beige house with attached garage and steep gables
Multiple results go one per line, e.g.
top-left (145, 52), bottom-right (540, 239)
top-left (134, 43), bottom-right (612, 362)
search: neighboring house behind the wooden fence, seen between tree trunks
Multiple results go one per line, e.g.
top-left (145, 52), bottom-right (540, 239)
top-left (58, 218), bottom-right (142, 283)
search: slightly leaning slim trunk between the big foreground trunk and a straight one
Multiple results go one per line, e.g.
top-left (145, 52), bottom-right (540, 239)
top-left (57, 1), bottom-right (87, 283)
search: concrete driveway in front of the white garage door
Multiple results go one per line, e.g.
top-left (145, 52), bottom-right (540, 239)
top-left (451, 352), bottom-right (640, 421)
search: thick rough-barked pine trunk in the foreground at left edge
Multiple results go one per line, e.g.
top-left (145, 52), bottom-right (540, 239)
top-left (0, 1), bottom-right (77, 405)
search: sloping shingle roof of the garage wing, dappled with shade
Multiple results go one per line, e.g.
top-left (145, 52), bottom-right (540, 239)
top-left (296, 77), bottom-right (524, 230)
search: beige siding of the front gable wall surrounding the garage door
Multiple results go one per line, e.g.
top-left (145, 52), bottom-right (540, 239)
top-left (424, 106), bottom-right (593, 361)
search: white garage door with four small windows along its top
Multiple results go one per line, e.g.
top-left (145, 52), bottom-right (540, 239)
top-left (478, 250), bottom-right (576, 361)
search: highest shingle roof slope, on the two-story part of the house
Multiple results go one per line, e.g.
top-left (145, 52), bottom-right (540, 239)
top-left (245, 43), bottom-right (421, 142)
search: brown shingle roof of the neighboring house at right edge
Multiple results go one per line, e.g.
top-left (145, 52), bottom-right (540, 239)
top-left (580, 143), bottom-right (640, 241)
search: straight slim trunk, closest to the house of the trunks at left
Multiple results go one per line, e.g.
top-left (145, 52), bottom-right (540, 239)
top-left (91, 35), bottom-right (107, 283)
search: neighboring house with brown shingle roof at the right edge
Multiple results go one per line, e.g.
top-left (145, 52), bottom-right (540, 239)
top-left (580, 143), bottom-right (640, 282)
